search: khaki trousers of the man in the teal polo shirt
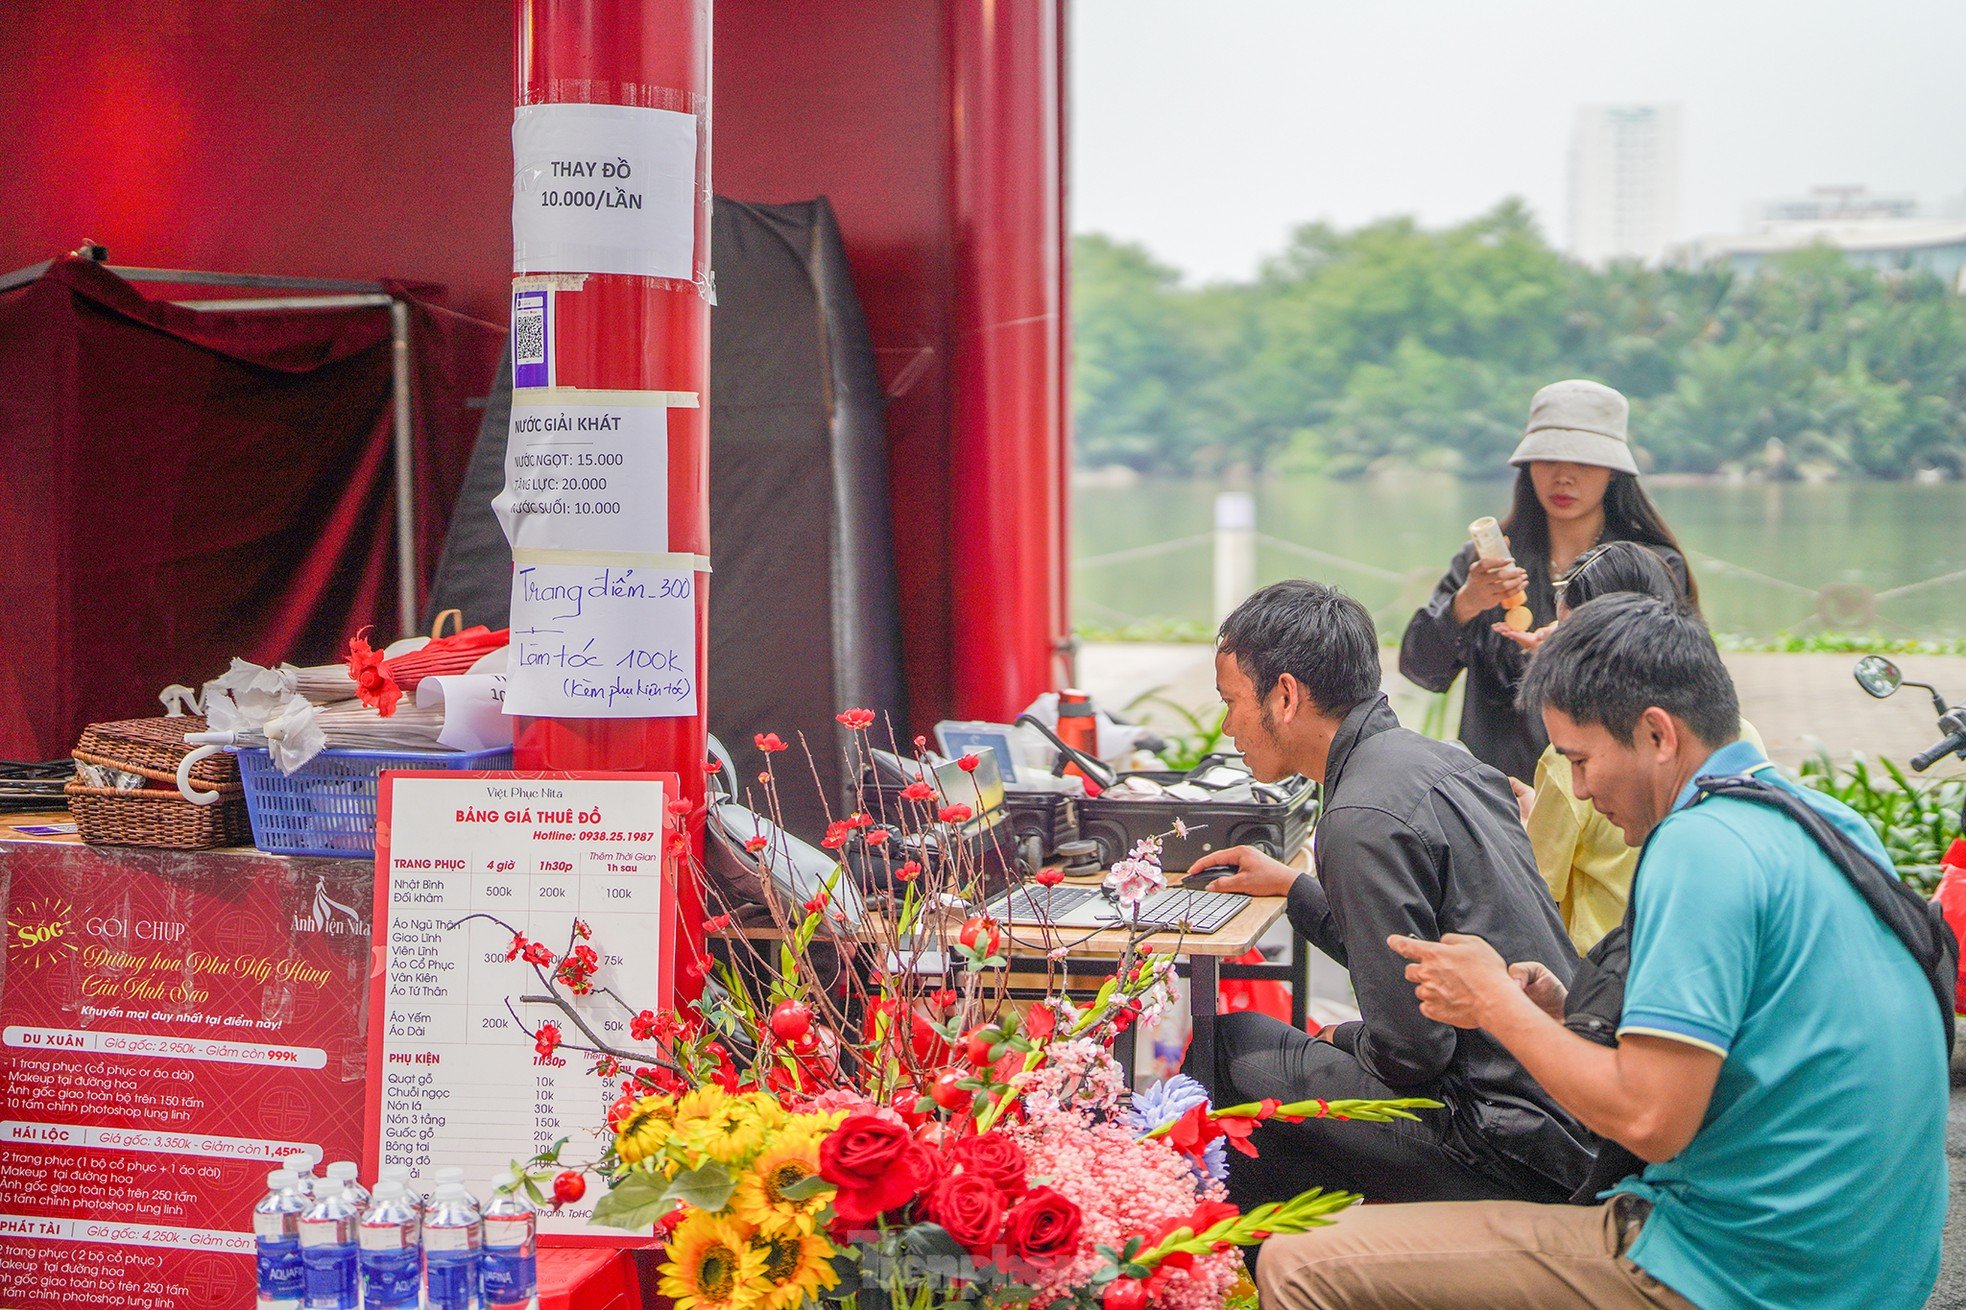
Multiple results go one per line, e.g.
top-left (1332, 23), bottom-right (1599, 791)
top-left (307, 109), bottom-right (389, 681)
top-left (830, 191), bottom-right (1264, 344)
top-left (1256, 1196), bottom-right (1693, 1310)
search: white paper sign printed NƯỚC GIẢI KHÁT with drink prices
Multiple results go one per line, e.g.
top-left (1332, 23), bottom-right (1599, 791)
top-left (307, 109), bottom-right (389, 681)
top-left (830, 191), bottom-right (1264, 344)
top-left (492, 389), bottom-right (696, 553)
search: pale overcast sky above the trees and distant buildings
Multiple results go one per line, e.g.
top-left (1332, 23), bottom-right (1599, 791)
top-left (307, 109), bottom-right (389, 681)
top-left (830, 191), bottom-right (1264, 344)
top-left (1070, 0), bottom-right (1966, 279)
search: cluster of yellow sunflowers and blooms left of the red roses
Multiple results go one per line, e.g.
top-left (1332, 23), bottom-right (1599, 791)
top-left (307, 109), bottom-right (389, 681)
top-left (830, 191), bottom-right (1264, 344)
top-left (615, 1086), bottom-right (843, 1310)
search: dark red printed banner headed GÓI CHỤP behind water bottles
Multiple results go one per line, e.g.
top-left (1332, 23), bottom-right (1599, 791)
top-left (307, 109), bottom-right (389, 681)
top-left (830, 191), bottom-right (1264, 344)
top-left (0, 842), bottom-right (374, 1310)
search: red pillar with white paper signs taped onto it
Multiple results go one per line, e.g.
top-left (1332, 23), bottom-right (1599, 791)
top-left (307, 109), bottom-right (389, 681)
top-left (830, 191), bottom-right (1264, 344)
top-left (513, 0), bottom-right (710, 963)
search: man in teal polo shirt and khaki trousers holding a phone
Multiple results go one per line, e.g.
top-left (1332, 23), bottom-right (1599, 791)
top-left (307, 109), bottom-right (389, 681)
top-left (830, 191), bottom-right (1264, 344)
top-left (1258, 596), bottom-right (1946, 1310)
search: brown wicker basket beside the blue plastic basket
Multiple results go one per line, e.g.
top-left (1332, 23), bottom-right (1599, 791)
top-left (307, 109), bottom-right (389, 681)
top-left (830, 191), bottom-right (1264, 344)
top-left (65, 718), bottom-right (252, 850)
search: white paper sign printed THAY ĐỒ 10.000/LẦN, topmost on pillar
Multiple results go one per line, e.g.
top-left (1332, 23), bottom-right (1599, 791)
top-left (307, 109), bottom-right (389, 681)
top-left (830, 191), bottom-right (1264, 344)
top-left (511, 104), bottom-right (696, 281)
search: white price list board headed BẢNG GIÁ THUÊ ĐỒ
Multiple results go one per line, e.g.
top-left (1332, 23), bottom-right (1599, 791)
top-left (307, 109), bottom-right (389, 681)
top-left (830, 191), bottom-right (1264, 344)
top-left (368, 773), bottom-right (676, 1241)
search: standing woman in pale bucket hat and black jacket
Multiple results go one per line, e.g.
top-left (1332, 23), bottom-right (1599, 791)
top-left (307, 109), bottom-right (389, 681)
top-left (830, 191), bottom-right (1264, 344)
top-left (1400, 380), bottom-right (1699, 783)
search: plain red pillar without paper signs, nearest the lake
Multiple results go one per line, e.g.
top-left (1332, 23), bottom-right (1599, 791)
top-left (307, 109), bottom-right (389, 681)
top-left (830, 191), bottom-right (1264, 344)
top-left (948, 0), bottom-right (1068, 720)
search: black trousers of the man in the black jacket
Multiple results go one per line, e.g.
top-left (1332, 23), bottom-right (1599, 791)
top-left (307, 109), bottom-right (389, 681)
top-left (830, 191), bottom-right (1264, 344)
top-left (1187, 1013), bottom-right (1567, 1210)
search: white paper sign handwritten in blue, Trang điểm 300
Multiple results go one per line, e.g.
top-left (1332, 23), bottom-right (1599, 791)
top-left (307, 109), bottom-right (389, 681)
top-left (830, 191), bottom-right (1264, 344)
top-left (505, 559), bottom-right (696, 718)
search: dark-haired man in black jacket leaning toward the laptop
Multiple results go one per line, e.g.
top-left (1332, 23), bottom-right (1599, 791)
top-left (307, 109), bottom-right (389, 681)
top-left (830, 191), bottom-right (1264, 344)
top-left (1189, 580), bottom-right (1592, 1208)
